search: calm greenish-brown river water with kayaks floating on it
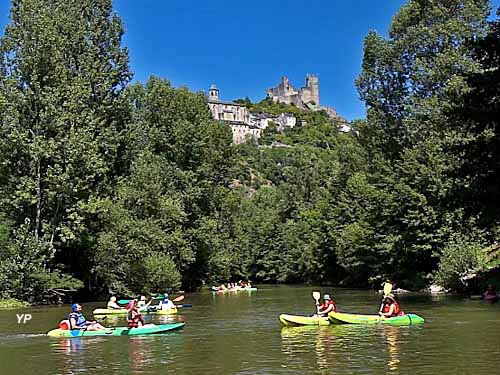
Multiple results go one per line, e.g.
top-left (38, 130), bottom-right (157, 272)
top-left (0, 286), bottom-right (500, 375)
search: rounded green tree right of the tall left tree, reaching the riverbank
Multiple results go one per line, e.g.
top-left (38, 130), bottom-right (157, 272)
top-left (95, 77), bottom-right (234, 293)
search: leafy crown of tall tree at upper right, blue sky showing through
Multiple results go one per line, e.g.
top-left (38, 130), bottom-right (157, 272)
top-left (356, 0), bottom-right (490, 154)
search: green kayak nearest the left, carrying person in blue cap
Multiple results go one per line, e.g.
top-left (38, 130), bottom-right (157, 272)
top-left (47, 323), bottom-right (185, 337)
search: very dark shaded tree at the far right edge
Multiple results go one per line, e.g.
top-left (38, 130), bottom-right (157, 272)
top-left (450, 8), bottom-right (500, 226)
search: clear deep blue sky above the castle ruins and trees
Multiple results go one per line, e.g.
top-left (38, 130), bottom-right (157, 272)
top-left (0, 0), bottom-right (500, 119)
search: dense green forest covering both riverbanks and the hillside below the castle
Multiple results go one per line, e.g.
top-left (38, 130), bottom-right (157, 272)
top-left (0, 0), bottom-right (500, 302)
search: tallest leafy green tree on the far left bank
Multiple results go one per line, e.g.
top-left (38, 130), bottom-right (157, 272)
top-left (0, 0), bottom-right (131, 300)
